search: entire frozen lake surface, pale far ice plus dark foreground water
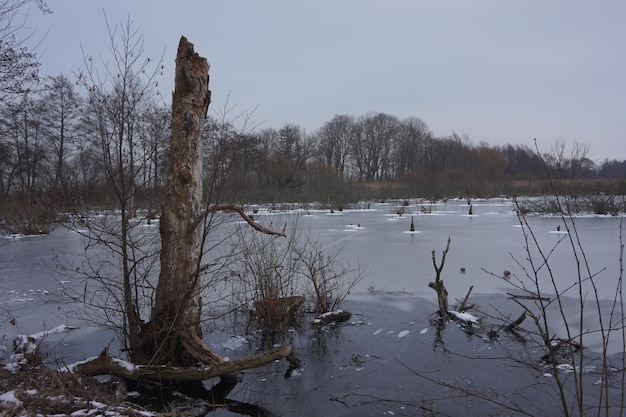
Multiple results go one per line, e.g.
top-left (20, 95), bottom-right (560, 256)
top-left (0, 200), bottom-right (623, 416)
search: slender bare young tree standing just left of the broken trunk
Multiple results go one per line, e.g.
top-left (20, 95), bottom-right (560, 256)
top-left (73, 16), bottom-right (162, 350)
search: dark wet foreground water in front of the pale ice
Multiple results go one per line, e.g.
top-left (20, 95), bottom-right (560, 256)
top-left (200, 293), bottom-right (619, 416)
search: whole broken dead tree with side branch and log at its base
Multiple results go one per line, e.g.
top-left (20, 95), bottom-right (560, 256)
top-left (78, 37), bottom-right (295, 381)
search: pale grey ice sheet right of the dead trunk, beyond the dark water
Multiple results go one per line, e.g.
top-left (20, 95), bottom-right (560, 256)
top-left (266, 200), bottom-right (621, 300)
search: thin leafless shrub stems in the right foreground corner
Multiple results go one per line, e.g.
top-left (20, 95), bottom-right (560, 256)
top-left (500, 196), bottom-right (626, 416)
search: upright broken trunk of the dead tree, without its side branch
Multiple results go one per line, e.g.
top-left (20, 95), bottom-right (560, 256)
top-left (131, 36), bottom-right (210, 365)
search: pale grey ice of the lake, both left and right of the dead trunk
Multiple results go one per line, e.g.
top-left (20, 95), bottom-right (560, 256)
top-left (0, 199), bottom-right (621, 353)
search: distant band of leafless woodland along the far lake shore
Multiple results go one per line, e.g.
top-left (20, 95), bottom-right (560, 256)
top-left (0, 75), bottom-right (626, 213)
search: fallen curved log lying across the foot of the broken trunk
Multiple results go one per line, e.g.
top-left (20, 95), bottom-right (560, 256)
top-left (71, 345), bottom-right (293, 381)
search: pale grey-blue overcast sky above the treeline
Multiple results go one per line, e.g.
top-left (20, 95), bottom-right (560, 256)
top-left (28, 0), bottom-right (626, 161)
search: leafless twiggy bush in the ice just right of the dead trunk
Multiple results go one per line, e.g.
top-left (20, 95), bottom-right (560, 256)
top-left (231, 214), bottom-right (365, 329)
